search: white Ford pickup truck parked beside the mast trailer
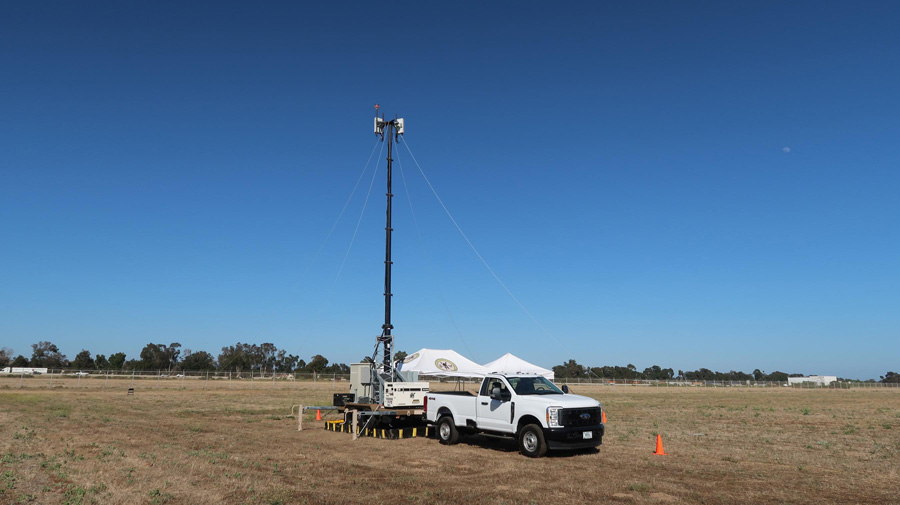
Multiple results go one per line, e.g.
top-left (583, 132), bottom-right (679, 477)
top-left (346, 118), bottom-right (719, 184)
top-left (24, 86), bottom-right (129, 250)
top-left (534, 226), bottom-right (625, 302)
top-left (424, 374), bottom-right (604, 458)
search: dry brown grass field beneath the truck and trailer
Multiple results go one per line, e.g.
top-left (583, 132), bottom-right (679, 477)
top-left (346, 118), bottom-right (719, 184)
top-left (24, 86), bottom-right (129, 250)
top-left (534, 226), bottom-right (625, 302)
top-left (0, 378), bottom-right (900, 505)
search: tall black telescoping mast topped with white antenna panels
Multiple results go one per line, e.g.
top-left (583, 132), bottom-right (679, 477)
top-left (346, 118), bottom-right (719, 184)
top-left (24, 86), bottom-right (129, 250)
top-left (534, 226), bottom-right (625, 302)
top-left (375, 104), bottom-right (403, 380)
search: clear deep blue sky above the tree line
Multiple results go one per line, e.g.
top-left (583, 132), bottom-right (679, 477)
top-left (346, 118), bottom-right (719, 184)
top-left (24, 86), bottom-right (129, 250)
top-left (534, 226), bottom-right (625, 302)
top-left (0, 1), bottom-right (900, 379)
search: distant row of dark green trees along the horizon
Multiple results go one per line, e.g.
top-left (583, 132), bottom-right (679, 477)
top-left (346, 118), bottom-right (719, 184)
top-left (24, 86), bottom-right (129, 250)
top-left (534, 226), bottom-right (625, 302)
top-left (0, 341), bottom-right (900, 383)
